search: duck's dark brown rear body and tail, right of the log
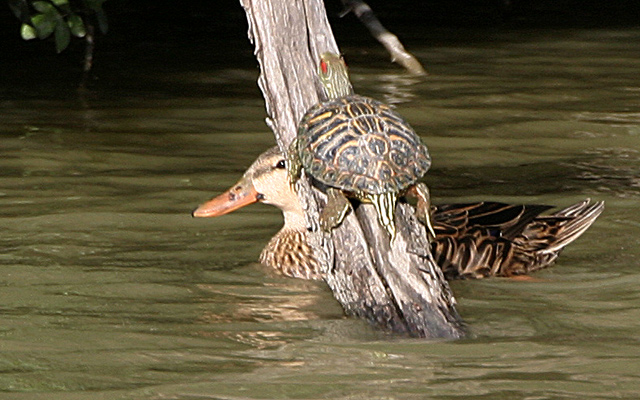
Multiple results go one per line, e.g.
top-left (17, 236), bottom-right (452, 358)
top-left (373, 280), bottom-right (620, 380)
top-left (432, 200), bottom-right (604, 279)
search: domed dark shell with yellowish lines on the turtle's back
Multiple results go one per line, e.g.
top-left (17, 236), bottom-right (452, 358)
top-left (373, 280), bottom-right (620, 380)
top-left (297, 95), bottom-right (431, 194)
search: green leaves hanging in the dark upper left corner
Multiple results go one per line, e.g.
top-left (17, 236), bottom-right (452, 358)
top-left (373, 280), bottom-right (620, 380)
top-left (8, 0), bottom-right (108, 53)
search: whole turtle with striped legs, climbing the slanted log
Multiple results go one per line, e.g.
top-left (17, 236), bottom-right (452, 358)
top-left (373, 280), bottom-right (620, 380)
top-left (288, 53), bottom-right (435, 239)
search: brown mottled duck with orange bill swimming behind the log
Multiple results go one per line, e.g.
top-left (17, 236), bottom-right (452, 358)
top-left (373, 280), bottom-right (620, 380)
top-left (192, 146), bottom-right (604, 280)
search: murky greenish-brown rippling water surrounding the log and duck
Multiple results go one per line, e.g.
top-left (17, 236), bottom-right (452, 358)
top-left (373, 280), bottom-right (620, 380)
top-left (0, 30), bottom-right (640, 399)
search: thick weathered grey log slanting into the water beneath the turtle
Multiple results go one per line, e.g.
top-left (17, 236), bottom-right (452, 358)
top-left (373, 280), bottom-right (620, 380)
top-left (241, 0), bottom-right (463, 338)
